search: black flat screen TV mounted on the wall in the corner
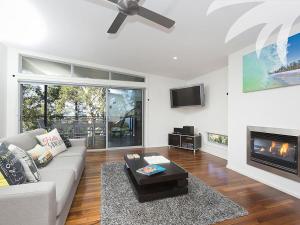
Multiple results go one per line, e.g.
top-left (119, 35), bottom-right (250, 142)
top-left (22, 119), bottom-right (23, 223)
top-left (170, 84), bottom-right (205, 108)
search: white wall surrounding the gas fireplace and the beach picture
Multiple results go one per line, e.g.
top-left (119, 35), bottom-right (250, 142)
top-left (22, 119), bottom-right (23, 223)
top-left (228, 46), bottom-right (300, 198)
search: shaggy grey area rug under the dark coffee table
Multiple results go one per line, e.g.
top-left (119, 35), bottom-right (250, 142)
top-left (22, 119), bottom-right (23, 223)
top-left (101, 162), bottom-right (248, 225)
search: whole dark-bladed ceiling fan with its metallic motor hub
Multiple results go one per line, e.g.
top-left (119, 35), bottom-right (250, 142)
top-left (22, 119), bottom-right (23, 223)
top-left (107, 0), bottom-right (175, 34)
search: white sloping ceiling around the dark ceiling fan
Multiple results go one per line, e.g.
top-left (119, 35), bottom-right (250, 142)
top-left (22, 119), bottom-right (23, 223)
top-left (3, 0), bottom-right (259, 79)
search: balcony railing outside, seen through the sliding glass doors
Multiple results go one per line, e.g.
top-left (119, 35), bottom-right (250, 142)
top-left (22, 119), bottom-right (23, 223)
top-left (28, 116), bottom-right (136, 149)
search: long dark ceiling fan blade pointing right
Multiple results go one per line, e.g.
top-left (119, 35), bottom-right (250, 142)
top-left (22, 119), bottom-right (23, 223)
top-left (138, 6), bottom-right (175, 28)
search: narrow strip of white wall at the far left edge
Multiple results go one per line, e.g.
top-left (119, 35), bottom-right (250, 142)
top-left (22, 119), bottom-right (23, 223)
top-left (0, 43), bottom-right (6, 138)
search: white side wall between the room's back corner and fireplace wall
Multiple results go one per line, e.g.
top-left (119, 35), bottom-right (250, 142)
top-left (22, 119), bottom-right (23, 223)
top-left (181, 67), bottom-right (228, 159)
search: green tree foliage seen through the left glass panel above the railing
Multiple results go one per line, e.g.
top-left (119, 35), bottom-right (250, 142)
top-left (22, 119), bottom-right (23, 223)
top-left (22, 84), bottom-right (106, 130)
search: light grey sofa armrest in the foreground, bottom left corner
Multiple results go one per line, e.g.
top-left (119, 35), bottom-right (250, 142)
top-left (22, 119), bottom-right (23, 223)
top-left (0, 182), bottom-right (56, 225)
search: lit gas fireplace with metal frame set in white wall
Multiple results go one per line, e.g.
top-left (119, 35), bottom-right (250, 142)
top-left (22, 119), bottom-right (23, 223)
top-left (247, 127), bottom-right (300, 181)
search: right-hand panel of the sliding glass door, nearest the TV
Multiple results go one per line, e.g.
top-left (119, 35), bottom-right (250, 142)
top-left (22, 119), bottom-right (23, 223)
top-left (107, 89), bottom-right (143, 148)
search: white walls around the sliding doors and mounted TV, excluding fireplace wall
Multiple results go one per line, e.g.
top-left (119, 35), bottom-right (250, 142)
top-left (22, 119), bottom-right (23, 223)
top-left (1, 47), bottom-right (227, 150)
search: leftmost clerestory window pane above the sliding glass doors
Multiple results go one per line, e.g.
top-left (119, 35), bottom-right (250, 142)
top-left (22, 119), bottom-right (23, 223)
top-left (20, 56), bottom-right (71, 76)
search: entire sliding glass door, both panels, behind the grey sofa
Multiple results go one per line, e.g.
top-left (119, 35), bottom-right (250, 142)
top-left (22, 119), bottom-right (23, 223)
top-left (20, 84), bottom-right (143, 149)
